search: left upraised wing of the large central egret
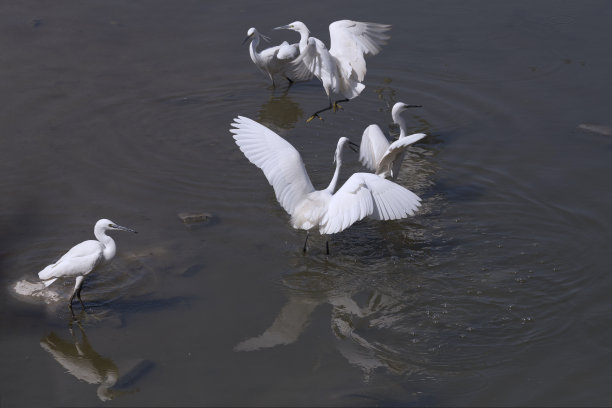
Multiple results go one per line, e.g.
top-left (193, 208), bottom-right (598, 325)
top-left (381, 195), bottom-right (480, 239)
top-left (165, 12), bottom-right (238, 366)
top-left (230, 116), bottom-right (314, 215)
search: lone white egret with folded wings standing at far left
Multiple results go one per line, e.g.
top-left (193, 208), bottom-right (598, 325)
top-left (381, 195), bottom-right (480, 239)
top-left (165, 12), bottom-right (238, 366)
top-left (38, 218), bottom-right (136, 311)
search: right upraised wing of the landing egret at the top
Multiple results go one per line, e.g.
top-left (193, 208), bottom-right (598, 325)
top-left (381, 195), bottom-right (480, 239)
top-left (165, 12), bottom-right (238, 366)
top-left (329, 20), bottom-right (391, 82)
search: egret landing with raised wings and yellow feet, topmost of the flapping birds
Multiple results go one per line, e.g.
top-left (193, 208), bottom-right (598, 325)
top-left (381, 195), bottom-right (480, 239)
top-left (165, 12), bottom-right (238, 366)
top-left (275, 20), bottom-right (391, 122)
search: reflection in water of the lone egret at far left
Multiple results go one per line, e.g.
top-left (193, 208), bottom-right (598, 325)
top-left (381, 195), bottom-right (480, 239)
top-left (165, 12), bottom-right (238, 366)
top-left (40, 321), bottom-right (142, 401)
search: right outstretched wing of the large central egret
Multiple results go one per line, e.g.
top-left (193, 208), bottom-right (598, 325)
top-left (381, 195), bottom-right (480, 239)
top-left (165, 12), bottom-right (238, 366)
top-left (319, 173), bottom-right (421, 234)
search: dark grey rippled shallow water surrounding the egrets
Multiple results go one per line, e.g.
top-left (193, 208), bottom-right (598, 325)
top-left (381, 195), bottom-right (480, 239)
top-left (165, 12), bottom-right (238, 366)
top-left (0, 1), bottom-right (612, 406)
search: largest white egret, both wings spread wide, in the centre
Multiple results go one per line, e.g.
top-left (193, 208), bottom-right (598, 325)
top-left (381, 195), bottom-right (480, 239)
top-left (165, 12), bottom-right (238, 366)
top-left (230, 116), bottom-right (421, 254)
